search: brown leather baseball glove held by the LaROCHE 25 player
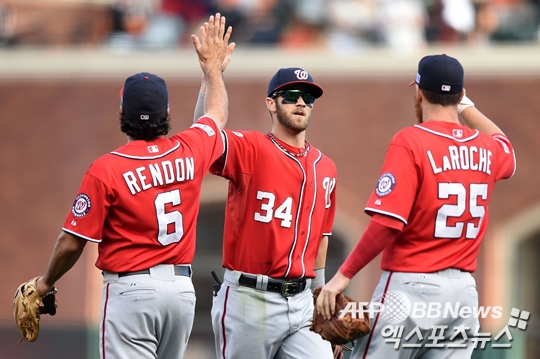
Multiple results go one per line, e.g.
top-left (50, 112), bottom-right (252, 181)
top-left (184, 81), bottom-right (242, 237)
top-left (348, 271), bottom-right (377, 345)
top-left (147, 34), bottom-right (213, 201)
top-left (309, 287), bottom-right (371, 346)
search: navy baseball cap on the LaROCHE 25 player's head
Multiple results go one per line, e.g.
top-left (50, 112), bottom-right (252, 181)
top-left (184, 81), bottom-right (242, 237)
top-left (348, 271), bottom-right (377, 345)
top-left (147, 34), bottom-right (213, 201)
top-left (411, 54), bottom-right (464, 94)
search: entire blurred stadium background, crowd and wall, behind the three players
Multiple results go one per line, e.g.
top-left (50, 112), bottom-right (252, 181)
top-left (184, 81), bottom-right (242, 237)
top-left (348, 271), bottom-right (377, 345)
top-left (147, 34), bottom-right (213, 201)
top-left (0, 0), bottom-right (540, 359)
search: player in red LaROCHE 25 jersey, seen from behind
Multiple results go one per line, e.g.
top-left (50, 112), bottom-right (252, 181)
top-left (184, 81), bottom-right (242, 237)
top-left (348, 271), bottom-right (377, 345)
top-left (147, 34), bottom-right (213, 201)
top-left (317, 55), bottom-right (516, 359)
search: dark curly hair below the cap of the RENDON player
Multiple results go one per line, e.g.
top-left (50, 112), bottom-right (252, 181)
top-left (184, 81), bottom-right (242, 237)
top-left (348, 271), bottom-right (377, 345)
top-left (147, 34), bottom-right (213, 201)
top-left (120, 113), bottom-right (171, 141)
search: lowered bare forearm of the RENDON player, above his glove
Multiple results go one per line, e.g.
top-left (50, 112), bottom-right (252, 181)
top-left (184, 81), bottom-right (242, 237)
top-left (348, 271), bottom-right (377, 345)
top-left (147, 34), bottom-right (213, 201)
top-left (42, 232), bottom-right (87, 287)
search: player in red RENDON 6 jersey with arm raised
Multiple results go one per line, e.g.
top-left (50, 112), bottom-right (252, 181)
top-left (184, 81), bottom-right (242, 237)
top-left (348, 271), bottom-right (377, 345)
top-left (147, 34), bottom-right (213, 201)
top-left (15, 14), bottom-right (231, 359)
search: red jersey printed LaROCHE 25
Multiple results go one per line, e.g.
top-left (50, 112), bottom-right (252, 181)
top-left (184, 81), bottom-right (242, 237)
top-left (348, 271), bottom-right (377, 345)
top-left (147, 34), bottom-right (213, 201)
top-left (365, 121), bottom-right (516, 272)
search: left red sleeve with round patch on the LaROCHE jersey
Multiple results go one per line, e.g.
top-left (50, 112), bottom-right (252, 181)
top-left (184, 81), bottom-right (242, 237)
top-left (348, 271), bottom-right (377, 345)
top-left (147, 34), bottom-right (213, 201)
top-left (364, 139), bottom-right (420, 225)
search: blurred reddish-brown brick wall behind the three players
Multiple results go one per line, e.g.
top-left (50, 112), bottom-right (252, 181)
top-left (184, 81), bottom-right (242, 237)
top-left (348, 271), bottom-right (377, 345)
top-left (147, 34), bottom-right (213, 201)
top-left (0, 68), bottom-right (540, 359)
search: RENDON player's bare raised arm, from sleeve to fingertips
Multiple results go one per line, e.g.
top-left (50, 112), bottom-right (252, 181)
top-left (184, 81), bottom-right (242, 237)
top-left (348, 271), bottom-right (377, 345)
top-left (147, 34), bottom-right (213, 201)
top-left (191, 13), bottom-right (235, 129)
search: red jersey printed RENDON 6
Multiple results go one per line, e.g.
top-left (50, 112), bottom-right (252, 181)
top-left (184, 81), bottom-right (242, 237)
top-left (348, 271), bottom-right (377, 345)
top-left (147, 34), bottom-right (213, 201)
top-left (63, 117), bottom-right (224, 272)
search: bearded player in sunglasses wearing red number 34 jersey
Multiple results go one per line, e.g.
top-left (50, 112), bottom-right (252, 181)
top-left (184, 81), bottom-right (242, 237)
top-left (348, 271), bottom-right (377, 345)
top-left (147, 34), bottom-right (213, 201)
top-left (194, 67), bottom-right (337, 359)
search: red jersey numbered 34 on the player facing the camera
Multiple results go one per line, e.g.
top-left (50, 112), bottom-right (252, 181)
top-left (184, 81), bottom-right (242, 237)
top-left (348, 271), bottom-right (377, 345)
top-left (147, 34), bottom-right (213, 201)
top-left (210, 130), bottom-right (337, 278)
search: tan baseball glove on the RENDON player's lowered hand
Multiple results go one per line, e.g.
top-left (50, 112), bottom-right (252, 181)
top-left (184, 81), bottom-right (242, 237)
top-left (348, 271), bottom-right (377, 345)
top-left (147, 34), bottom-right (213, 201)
top-left (13, 277), bottom-right (57, 344)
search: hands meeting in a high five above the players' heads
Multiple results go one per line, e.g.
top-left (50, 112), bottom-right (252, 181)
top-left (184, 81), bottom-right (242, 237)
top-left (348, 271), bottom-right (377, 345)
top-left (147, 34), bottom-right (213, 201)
top-left (191, 13), bottom-right (236, 73)
